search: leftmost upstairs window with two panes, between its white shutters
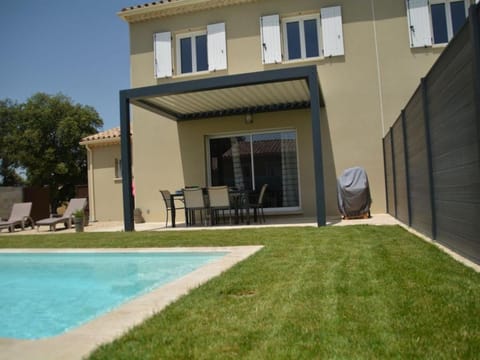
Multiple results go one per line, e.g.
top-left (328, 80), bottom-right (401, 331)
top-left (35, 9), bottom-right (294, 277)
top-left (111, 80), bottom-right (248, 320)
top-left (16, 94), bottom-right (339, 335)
top-left (177, 31), bottom-right (208, 74)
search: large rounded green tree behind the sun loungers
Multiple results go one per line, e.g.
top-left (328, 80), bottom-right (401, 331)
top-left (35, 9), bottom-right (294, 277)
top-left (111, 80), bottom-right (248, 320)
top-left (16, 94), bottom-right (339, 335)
top-left (4, 93), bottom-right (103, 211)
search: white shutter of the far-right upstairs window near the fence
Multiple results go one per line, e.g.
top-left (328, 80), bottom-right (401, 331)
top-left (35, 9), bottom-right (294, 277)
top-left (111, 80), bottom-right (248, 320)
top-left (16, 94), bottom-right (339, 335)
top-left (406, 0), bottom-right (432, 48)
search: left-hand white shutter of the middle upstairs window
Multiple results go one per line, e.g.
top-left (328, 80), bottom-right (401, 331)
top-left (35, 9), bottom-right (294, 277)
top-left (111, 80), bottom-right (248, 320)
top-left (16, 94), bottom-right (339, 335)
top-left (260, 15), bottom-right (282, 64)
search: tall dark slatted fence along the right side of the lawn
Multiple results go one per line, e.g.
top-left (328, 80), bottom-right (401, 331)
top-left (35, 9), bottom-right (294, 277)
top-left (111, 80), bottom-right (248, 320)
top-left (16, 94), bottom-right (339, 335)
top-left (383, 5), bottom-right (480, 263)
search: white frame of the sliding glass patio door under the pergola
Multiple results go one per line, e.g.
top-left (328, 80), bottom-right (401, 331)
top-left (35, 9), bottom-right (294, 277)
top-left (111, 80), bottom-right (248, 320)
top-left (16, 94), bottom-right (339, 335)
top-left (205, 128), bottom-right (303, 214)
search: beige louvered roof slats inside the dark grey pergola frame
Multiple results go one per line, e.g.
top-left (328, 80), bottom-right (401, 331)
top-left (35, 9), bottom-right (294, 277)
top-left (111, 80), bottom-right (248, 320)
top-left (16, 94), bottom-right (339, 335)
top-left (132, 79), bottom-right (310, 120)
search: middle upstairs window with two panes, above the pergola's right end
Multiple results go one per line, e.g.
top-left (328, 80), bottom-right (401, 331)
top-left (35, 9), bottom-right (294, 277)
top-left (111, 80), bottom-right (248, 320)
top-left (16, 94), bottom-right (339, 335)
top-left (283, 15), bottom-right (321, 60)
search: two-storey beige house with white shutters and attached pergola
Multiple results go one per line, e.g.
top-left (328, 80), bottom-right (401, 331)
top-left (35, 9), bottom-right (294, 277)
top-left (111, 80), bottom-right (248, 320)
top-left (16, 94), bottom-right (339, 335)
top-left (101, 0), bottom-right (473, 230)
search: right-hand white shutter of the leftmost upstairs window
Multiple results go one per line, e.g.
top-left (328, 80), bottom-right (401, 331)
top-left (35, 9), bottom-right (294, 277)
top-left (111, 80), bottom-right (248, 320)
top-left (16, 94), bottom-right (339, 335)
top-left (207, 23), bottom-right (227, 71)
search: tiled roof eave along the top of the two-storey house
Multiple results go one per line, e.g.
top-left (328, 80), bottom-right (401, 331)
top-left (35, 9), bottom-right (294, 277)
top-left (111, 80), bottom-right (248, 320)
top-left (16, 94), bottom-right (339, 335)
top-left (117, 0), bottom-right (258, 23)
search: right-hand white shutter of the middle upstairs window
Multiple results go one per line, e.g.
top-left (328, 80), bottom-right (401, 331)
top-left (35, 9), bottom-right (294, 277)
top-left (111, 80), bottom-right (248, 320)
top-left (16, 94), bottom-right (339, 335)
top-left (321, 6), bottom-right (345, 56)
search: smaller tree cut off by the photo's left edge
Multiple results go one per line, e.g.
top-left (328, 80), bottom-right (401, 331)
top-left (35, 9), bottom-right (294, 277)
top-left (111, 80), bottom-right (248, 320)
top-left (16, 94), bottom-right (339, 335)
top-left (0, 99), bottom-right (23, 186)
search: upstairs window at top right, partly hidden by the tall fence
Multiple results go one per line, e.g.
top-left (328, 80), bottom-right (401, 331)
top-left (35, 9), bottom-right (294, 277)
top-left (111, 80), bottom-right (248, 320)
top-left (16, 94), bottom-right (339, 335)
top-left (430, 0), bottom-right (468, 44)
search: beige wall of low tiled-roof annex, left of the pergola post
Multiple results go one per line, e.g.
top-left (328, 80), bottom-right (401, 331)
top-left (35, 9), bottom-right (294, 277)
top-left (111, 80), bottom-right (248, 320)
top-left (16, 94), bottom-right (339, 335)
top-left (88, 144), bottom-right (123, 221)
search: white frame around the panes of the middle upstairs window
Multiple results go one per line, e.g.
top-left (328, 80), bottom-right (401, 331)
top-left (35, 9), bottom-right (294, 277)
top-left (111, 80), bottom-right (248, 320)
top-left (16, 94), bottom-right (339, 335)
top-left (280, 13), bottom-right (323, 62)
